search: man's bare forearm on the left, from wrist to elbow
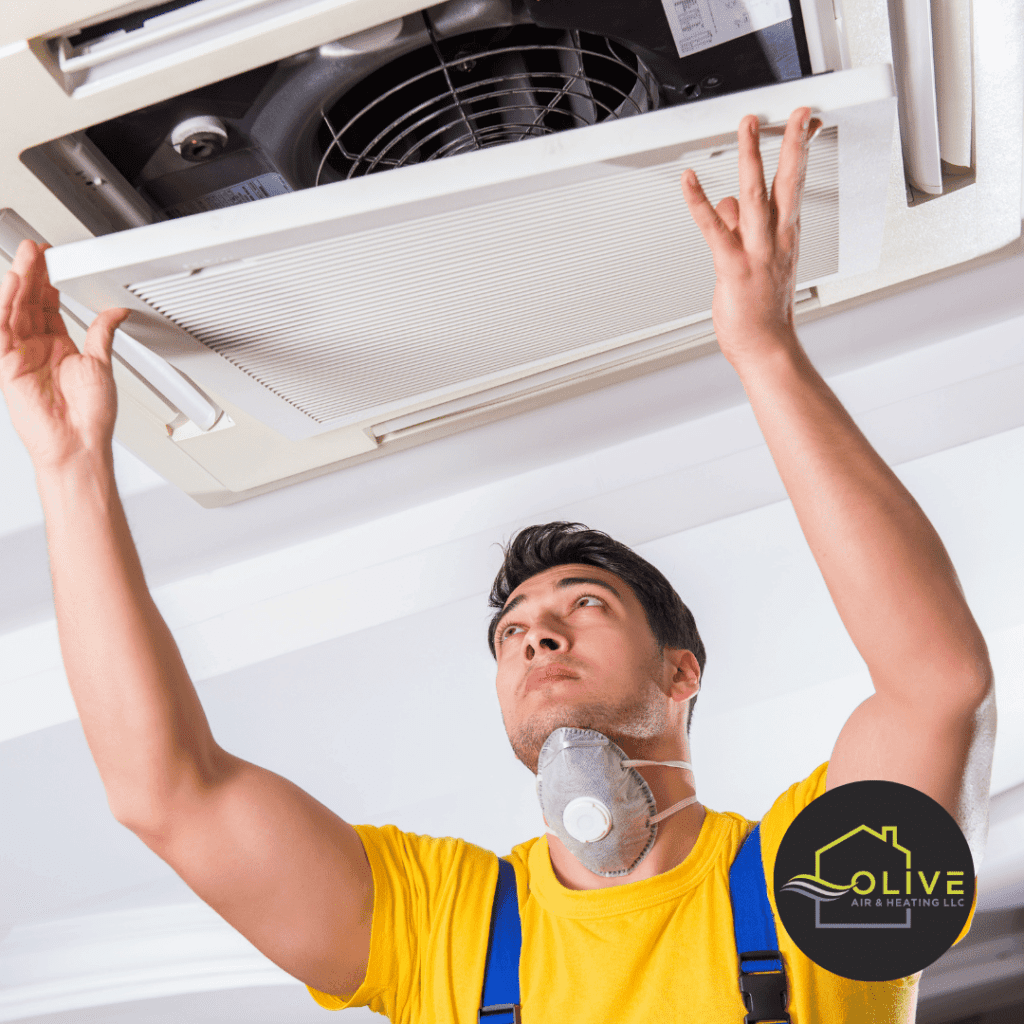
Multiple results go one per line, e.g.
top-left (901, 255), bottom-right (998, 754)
top-left (36, 457), bottom-right (222, 824)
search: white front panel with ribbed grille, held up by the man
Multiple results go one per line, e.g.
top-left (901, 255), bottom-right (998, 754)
top-left (49, 66), bottom-right (895, 443)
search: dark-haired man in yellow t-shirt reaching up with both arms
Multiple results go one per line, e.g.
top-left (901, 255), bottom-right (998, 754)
top-left (0, 108), bottom-right (994, 1024)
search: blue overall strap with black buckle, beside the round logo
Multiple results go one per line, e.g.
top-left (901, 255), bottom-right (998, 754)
top-left (729, 821), bottom-right (790, 1024)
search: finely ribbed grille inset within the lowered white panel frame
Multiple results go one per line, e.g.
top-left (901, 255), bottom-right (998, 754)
top-left (130, 128), bottom-right (839, 426)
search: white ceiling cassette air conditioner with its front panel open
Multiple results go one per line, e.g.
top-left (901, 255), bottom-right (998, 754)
top-left (0, 0), bottom-right (1021, 507)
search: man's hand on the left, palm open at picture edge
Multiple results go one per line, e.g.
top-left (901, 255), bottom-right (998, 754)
top-left (0, 240), bottom-right (130, 470)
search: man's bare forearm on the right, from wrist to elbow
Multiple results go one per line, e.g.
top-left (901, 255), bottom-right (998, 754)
top-left (737, 336), bottom-right (990, 702)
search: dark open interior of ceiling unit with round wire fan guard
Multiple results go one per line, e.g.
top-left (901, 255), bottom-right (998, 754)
top-left (22, 0), bottom-right (811, 234)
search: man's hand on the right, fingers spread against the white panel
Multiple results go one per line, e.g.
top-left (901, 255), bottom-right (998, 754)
top-left (682, 106), bottom-right (821, 370)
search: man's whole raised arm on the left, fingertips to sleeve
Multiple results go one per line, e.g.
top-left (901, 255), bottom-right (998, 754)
top-left (0, 242), bottom-right (374, 995)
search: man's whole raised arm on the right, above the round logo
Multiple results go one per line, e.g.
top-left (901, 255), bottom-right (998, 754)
top-left (683, 108), bottom-right (995, 862)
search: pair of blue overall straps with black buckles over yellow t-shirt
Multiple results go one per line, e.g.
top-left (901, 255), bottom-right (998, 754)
top-left (477, 822), bottom-right (790, 1024)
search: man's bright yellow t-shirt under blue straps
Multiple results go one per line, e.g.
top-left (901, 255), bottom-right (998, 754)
top-left (307, 762), bottom-right (974, 1024)
